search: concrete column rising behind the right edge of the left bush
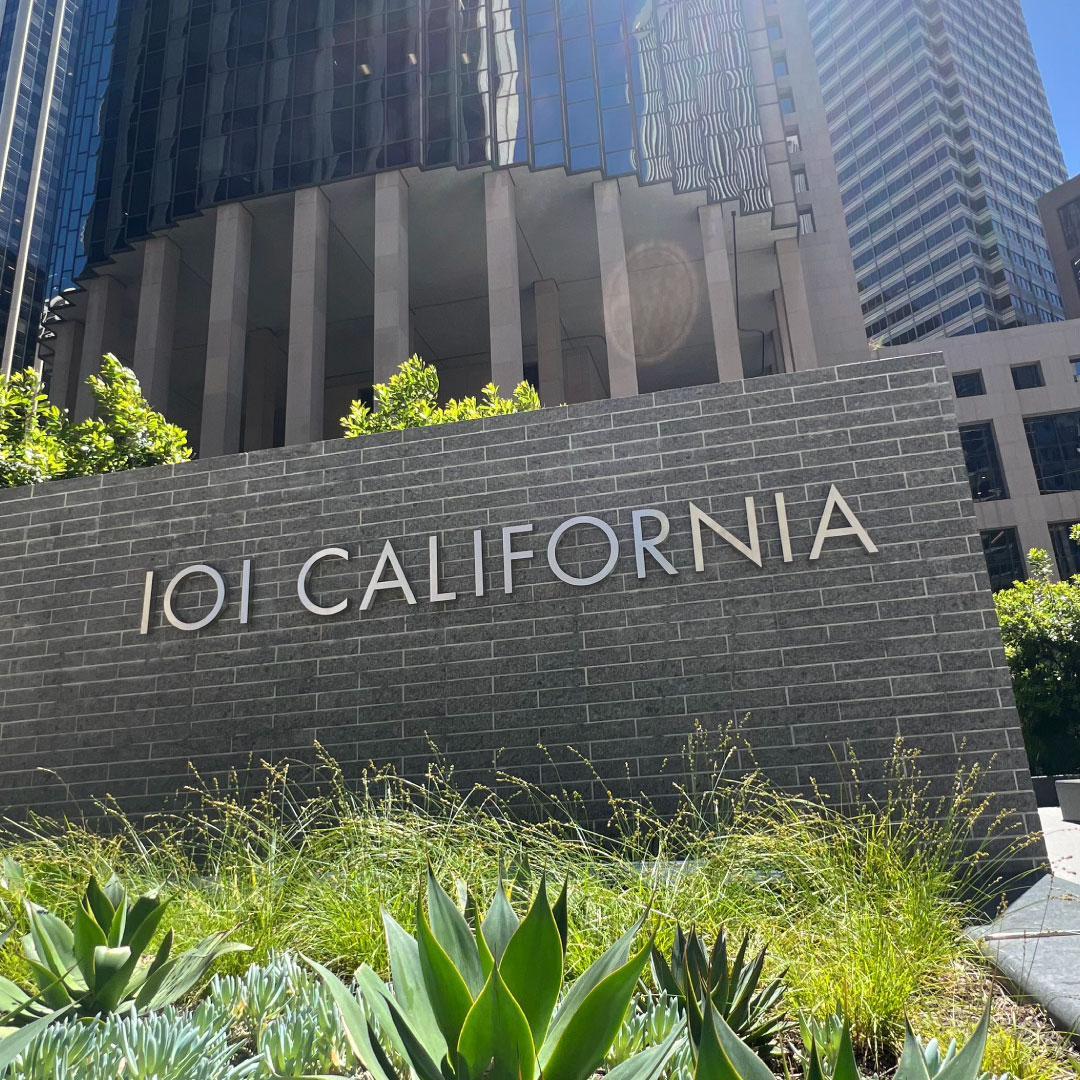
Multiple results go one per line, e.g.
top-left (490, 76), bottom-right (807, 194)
top-left (135, 237), bottom-right (180, 413)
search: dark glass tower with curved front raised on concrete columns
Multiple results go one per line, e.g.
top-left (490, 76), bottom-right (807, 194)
top-left (49, 0), bottom-right (866, 456)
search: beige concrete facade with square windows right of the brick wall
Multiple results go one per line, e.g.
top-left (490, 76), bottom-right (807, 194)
top-left (875, 320), bottom-right (1080, 589)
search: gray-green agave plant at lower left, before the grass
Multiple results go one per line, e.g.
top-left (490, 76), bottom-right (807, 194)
top-left (0, 877), bottom-right (247, 1025)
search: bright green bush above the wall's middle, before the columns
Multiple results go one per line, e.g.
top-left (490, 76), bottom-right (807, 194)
top-left (341, 356), bottom-right (541, 438)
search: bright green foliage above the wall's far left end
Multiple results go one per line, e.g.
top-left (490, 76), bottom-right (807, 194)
top-left (0, 355), bottom-right (191, 487)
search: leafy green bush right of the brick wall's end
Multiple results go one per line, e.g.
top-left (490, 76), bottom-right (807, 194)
top-left (994, 537), bottom-right (1080, 775)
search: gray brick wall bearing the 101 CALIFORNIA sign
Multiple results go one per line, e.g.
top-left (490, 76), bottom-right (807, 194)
top-left (0, 355), bottom-right (1035, 842)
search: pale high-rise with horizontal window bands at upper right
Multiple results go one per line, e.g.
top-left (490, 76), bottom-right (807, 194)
top-left (794, 0), bottom-right (1066, 346)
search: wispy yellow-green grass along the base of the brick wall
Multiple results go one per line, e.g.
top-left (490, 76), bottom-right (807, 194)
top-left (0, 744), bottom-right (1052, 1076)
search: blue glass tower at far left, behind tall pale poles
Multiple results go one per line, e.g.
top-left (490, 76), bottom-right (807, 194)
top-left (0, 0), bottom-right (117, 373)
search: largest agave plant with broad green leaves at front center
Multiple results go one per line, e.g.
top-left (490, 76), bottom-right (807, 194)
top-left (308, 870), bottom-right (680, 1080)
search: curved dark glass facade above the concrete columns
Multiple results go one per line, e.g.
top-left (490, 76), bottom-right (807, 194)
top-left (86, 0), bottom-right (771, 261)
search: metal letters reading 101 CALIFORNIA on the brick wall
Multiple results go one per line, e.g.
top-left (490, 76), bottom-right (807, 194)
top-left (139, 485), bottom-right (878, 634)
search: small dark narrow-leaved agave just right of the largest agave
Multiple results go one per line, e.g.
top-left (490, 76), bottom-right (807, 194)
top-left (651, 927), bottom-right (788, 1062)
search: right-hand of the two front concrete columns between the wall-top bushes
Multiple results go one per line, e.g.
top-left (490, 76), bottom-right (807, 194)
top-left (285, 188), bottom-right (330, 446)
